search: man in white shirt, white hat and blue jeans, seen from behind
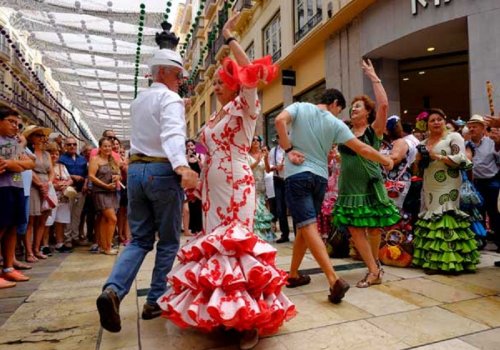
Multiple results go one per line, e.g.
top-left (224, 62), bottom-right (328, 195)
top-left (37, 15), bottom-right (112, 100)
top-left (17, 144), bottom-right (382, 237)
top-left (97, 49), bottom-right (198, 332)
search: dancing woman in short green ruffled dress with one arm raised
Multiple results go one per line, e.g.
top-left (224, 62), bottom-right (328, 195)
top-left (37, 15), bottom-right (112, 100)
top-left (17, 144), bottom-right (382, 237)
top-left (332, 60), bottom-right (400, 288)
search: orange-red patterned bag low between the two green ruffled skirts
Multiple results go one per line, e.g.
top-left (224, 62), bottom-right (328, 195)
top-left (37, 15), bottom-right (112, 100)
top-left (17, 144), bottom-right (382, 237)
top-left (378, 229), bottom-right (413, 267)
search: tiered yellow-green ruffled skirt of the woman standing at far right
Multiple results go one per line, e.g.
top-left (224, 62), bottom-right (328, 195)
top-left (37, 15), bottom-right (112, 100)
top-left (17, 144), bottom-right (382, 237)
top-left (413, 211), bottom-right (479, 273)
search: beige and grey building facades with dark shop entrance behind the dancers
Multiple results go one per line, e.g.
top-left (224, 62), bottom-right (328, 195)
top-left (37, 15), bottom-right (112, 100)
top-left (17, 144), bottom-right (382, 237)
top-left (181, 0), bottom-right (500, 144)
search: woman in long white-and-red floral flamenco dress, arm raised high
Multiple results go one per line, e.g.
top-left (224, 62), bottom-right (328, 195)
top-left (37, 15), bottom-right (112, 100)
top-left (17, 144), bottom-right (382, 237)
top-left (158, 13), bottom-right (295, 349)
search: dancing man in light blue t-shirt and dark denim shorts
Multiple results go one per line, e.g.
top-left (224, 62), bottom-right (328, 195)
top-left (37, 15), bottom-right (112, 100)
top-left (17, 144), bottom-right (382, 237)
top-left (275, 89), bottom-right (393, 304)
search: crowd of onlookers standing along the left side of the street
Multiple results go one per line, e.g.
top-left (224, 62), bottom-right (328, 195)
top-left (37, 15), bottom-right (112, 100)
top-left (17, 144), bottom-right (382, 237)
top-left (0, 108), bottom-right (130, 289)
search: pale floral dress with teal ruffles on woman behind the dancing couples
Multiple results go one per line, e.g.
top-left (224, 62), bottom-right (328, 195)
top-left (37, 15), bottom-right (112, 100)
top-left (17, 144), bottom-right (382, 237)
top-left (248, 154), bottom-right (276, 242)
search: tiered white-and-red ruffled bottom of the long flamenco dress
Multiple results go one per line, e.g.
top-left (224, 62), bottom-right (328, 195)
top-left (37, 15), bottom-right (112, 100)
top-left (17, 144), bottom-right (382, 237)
top-left (158, 222), bottom-right (296, 335)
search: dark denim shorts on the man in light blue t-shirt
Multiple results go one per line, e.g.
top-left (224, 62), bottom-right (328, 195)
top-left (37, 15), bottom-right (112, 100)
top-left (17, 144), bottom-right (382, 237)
top-left (285, 171), bottom-right (327, 228)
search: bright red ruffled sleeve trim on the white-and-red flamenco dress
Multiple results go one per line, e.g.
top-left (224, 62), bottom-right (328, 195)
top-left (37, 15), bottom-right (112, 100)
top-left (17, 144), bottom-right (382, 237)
top-left (219, 55), bottom-right (279, 91)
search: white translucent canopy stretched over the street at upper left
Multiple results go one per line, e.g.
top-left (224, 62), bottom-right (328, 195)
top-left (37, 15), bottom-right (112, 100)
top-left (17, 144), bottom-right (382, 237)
top-left (0, 0), bottom-right (178, 140)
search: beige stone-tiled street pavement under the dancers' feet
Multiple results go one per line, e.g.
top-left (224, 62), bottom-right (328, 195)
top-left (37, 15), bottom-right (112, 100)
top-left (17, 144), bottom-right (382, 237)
top-left (0, 244), bottom-right (500, 350)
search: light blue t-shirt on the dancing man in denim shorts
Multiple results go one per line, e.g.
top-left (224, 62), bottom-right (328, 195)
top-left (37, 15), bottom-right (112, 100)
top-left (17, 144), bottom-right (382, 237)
top-left (285, 102), bottom-right (354, 179)
